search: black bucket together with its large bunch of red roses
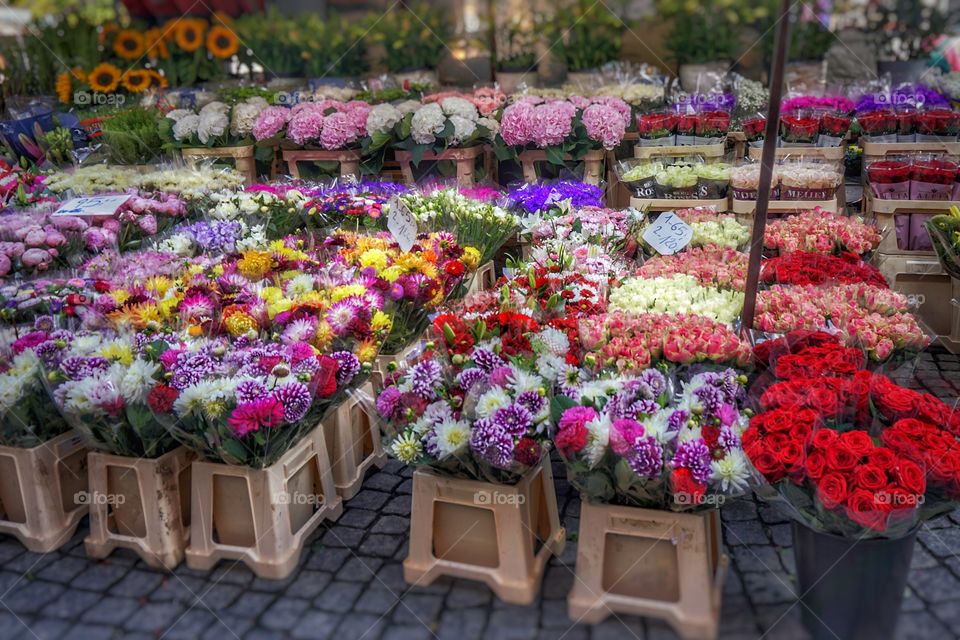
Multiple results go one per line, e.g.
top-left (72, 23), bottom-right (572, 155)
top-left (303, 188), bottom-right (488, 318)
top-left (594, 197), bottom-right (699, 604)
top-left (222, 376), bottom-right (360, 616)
top-left (743, 331), bottom-right (960, 640)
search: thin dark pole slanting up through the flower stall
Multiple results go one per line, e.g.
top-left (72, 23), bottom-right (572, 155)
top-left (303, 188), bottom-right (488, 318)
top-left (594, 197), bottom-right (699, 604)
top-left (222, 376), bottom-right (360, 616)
top-left (742, 0), bottom-right (790, 332)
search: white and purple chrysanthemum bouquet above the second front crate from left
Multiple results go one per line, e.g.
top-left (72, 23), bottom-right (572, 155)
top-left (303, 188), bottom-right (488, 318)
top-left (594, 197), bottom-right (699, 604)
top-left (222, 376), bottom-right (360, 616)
top-left (44, 332), bottom-right (176, 458)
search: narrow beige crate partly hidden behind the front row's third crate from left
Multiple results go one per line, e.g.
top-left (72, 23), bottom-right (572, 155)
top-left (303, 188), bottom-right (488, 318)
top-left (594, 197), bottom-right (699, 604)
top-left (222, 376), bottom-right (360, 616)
top-left (321, 382), bottom-right (387, 500)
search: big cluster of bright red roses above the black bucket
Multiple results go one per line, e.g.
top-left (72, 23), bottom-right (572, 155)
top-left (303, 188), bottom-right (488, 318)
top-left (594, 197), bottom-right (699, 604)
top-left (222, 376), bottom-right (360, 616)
top-left (743, 331), bottom-right (960, 532)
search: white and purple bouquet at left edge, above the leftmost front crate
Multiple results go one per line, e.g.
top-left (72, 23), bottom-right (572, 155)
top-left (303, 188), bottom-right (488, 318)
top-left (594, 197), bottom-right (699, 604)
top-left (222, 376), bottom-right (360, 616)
top-left (0, 324), bottom-right (73, 447)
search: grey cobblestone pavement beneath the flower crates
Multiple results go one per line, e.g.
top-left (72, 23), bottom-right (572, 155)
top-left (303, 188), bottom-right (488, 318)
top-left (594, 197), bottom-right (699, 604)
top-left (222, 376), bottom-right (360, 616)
top-left (0, 352), bottom-right (960, 640)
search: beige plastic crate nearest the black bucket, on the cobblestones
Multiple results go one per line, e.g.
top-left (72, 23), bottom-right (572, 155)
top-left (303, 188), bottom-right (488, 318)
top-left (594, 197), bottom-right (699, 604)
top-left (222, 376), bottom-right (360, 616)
top-left (567, 500), bottom-right (729, 640)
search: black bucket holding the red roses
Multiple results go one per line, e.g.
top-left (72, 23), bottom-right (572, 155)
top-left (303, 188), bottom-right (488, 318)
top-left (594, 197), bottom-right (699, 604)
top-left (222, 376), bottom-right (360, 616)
top-left (793, 522), bottom-right (917, 640)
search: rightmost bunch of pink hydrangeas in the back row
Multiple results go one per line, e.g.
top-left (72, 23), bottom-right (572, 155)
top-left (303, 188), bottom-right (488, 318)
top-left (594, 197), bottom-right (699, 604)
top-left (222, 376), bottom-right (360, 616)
top-left (497, 96), bottom-right (631, 165)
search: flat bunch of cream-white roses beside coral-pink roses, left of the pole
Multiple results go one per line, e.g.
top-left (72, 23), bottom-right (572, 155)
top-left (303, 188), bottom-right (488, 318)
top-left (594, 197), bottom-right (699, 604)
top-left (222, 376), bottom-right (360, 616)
top-left (608, 274), bottom-right (743, 324)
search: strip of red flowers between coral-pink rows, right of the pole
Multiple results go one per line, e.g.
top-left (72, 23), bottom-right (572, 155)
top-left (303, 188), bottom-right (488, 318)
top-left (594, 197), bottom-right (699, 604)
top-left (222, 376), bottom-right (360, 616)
top-left (760, 251), bottom-right (887, 289)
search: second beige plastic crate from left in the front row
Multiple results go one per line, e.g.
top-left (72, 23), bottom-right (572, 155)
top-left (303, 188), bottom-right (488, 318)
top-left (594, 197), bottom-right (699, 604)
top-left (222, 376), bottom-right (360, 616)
top-left (83, 447), bottom-right (197, 570)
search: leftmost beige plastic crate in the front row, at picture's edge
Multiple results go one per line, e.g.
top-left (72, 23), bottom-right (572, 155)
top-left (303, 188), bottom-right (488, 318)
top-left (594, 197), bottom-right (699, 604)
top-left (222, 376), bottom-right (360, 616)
top-left (0, 431), bottom-right (88, 553)
